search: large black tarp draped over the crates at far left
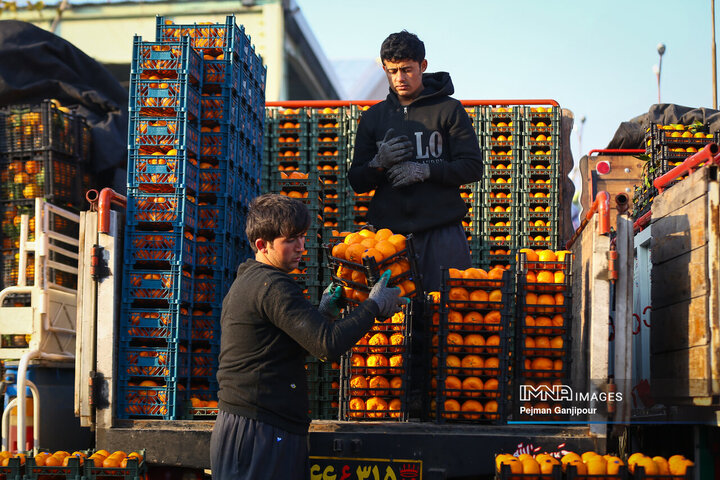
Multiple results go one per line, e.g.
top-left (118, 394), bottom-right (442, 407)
top-left (0, 20), bottom-right (128, 191)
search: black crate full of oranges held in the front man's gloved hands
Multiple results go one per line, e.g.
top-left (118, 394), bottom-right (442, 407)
top-left (324, 228), bottom-right (422, 303)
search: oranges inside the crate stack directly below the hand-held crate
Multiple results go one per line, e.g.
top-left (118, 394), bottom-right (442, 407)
top-left (348, 312), bottom-right (407, 419)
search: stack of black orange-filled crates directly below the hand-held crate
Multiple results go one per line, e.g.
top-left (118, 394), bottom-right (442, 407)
top-left (340, 305), bottom-right (412, 421)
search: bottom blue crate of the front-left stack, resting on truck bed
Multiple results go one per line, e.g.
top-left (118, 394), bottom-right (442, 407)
top-left (115, 377), bottom-right (187, 420)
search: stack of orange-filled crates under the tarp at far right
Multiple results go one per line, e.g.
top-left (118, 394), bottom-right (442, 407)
top-left (631, 123), bottom-right (720, 219)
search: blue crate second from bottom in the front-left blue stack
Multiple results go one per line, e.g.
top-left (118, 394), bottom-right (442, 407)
top-left (118, 341), bottom-right (190, 382)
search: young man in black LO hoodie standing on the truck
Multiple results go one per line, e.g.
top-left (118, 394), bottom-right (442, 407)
top-left (348, 30), bottom-right (483, 291)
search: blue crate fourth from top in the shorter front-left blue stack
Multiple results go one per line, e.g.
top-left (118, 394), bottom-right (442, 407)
top-left (128, 150), bottom-right (198, 193)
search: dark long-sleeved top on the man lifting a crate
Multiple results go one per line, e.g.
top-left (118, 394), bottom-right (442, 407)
top-left (217, 259), bottom-right (378, 435)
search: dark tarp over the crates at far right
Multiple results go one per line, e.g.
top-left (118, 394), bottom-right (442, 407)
top-left (607, 103), bottom-right (720, 149)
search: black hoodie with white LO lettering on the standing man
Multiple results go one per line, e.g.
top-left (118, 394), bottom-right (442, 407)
top-left (348, 72), bottom-right (483, 234)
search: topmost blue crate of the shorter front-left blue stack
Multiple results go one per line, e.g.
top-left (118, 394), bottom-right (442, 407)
top-left (130, 35), bottom-right (203, 84)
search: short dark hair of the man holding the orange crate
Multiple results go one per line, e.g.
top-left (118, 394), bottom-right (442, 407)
top-left (245, 193), bottom-right (310, 252)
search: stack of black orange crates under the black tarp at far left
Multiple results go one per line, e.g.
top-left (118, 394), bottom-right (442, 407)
top-left (0, 100), bottom-right (92, 289)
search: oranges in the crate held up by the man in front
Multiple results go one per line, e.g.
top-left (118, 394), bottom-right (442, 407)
top-left (330, 228), bottom-right (416, 302)
